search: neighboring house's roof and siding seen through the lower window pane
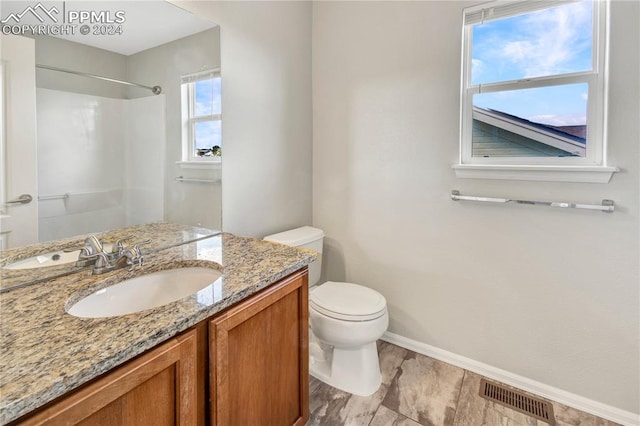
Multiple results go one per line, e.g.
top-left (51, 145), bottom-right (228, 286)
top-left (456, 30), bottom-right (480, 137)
top-left (473, 107), bottom-right (586, 157)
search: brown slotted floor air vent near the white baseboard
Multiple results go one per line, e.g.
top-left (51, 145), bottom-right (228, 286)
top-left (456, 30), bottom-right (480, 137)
top-left (480, 379), bottom-right (556, 425)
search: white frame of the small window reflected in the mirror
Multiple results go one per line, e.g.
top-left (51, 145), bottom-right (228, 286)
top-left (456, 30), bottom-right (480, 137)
top-left (178, 68), bottom-right (222, 167)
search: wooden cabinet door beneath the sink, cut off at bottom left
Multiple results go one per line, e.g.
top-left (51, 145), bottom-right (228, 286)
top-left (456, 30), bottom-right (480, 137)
top-left (20, 330), bottom-right (198, 426)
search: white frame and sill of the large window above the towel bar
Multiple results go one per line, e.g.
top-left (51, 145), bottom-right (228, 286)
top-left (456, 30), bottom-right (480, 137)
top-left (454, 0), bottom-right (618, 182)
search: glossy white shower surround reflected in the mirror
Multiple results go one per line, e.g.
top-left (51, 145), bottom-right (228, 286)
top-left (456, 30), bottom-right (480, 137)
top-left (36, 88), bottom-right (165, 241)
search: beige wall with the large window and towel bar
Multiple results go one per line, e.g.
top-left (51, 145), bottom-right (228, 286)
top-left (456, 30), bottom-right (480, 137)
top-left (312, 1), bottom-right (640, 413)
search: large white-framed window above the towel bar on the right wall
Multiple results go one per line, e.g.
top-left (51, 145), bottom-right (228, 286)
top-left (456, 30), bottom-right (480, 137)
top-left (455, 0), bottom-right (617, 181)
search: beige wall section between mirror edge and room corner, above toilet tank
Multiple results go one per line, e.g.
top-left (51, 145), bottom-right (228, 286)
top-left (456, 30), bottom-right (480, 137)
top-left (172, 1), bottom-right (311, 237)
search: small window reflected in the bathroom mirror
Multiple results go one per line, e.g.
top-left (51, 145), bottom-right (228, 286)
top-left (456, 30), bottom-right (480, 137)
top-left (182, 71), bottom-right (222, 162)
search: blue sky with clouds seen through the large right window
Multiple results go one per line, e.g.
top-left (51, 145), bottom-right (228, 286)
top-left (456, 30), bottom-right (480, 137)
top-left (471, 0), bottom-right (593, 126)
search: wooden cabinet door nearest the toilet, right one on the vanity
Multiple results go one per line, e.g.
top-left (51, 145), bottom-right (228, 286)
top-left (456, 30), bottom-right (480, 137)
top-left (209, 268), bottom-right (309, 426)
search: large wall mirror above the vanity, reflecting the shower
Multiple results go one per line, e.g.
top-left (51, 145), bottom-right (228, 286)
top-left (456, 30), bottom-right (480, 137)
top-left (0, 0), bottom-right (222, 255)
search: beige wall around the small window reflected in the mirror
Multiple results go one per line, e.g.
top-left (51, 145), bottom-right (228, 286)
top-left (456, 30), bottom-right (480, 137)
top-left (127, 27), bottom-right (226, 229)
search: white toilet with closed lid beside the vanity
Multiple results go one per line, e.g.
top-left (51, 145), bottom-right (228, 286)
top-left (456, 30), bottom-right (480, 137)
top-left (264, 226), bottom-right (389, 396)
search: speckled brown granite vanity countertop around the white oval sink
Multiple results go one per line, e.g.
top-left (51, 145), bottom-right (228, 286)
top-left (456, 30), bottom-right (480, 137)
top-left (0, 228), bottom-right (316, 424)
